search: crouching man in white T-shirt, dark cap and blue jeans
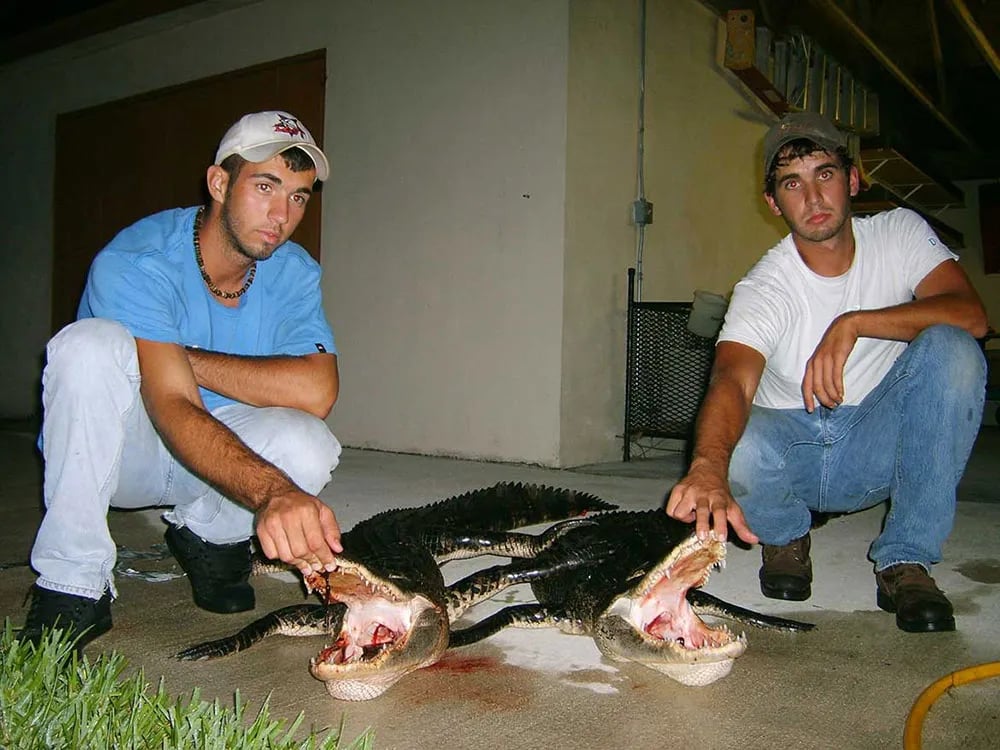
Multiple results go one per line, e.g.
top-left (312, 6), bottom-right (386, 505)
top-left (667, 112), bottom-right (987, 632)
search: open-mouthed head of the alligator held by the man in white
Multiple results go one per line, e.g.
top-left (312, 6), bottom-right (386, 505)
top-left (595, 533), bottom-right (747, 685)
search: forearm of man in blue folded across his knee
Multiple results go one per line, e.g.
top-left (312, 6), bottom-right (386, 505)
top-left (187, 349), bottom-right (339, 419)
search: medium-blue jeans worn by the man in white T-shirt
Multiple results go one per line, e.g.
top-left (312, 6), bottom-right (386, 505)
top-left (729, 325), bottom-right (986, 571)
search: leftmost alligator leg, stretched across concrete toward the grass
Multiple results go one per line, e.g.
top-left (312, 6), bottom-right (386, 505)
top-left (175, 603), bottom-right (347, 661)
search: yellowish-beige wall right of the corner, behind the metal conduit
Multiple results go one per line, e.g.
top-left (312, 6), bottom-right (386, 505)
top-left (562, 0), bottom-right (782, 465)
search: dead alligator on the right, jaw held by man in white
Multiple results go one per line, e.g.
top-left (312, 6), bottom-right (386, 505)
top-left (451, 511), bottom-right (813, 685)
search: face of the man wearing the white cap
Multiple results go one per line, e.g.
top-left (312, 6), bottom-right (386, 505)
top-left (220, 154), bottom-right (316, 260)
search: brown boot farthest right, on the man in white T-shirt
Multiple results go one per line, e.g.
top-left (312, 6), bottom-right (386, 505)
top-left (875, 563), bottom-right (955, 633)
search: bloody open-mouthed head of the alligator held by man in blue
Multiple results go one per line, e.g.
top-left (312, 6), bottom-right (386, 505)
top-left (306, 561), bottom-right (448, 701)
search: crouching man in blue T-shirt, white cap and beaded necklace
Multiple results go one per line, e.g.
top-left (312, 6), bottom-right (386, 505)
top-left (21, 112), bottom-right (341, 647)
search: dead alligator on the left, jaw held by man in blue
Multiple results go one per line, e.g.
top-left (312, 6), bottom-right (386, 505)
top-left (177, 483), bottom-right (616, 701)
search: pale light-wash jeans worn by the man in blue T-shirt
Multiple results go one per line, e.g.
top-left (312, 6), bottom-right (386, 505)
top-left (31, 318), bottom-right (340, 599)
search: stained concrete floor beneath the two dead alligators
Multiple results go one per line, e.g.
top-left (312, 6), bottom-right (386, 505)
top-left (0, 427), bottom-right (1000, 750)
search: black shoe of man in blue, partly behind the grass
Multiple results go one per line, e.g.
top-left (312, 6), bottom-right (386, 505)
top-left (18, 584), bottom-right (111, 654)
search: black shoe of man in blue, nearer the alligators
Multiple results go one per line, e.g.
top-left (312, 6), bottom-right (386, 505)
top-left (163, 524), bottom-right (255, 615)
